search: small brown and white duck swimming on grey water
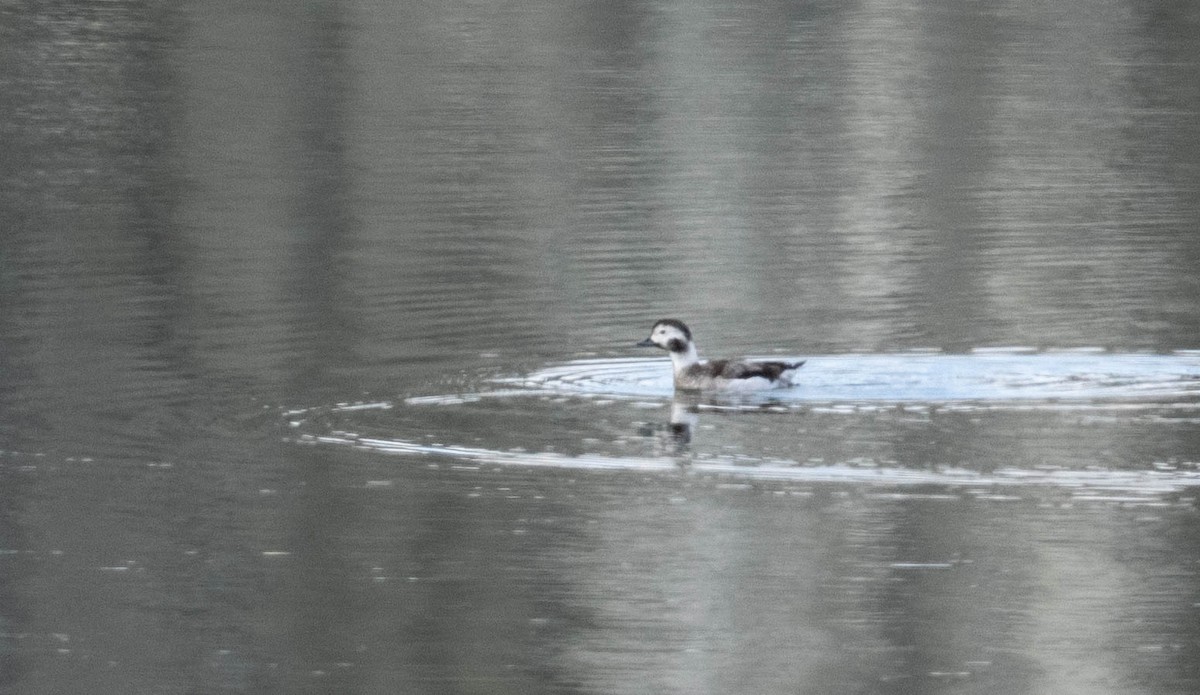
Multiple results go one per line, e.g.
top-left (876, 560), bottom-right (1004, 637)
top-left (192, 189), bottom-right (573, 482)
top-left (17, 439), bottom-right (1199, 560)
top-left (637, 318), bottom-right (804, 391)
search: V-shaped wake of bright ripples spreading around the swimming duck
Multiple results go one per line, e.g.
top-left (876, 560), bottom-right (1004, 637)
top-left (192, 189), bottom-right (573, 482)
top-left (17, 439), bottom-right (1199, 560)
top-left (284, 349), bottom-right (1200, 502)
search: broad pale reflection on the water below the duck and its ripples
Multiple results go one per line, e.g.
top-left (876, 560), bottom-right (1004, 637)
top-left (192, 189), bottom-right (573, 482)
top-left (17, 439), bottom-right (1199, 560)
top-left (556, 491), bottom-right (840, 693)
